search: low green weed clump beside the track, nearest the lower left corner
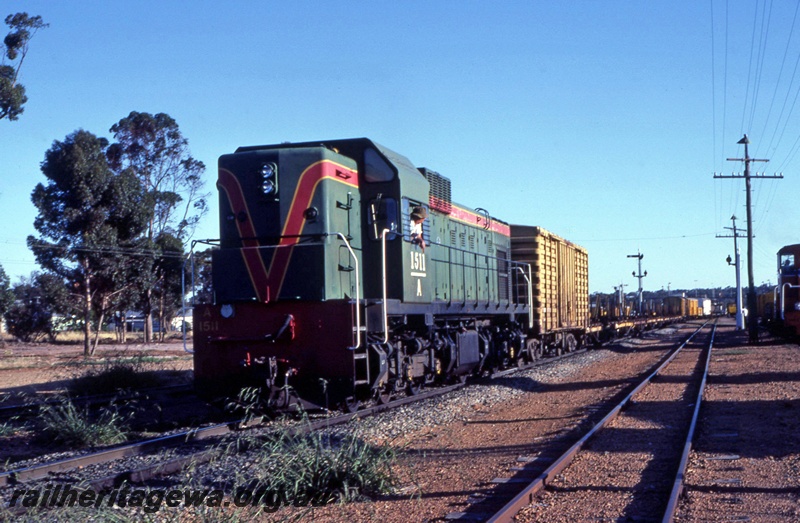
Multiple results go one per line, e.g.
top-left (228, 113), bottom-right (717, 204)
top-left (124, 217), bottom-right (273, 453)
top-left (39, 399), bottom-right (130, 447)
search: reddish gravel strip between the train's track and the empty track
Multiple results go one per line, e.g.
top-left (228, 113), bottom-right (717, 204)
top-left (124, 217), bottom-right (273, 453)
top-left (1, 330), bottom-right (674, 521)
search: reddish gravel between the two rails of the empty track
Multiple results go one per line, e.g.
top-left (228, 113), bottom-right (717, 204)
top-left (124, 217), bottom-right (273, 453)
top-left (517, 322), bottom-right (710, 523)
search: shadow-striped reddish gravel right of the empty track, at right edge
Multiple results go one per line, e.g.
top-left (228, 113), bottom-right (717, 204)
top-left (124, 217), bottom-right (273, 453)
top-left (676, 330), bottom-right (800, 522)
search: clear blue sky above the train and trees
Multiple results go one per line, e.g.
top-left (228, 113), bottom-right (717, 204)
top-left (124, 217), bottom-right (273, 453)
top-left (0, 0), bottom-right (800, 292)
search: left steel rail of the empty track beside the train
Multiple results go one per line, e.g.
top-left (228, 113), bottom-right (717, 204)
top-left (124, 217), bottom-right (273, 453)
top-left (487, 321), bottom-right (708, 523)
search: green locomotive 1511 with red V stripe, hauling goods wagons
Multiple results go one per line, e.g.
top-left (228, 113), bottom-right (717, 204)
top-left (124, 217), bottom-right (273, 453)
top-left (193, 138), bottom-right (685, 409)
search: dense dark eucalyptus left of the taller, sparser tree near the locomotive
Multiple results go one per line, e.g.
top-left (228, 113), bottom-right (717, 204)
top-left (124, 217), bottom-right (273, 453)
top-left (28, 130), bottom-right (150, 355)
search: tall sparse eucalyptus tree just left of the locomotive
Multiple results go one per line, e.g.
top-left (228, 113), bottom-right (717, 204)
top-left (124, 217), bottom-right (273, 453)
top-left (107, 111), bottom-right (208, 341)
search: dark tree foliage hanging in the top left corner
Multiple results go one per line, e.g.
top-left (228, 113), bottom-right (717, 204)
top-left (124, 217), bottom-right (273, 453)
top-left (0, 13), bottom-right (48, 120)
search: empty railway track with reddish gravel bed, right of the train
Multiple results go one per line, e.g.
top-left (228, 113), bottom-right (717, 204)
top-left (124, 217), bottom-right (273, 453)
top-left (447, 325), bottom-right (715, 522)
